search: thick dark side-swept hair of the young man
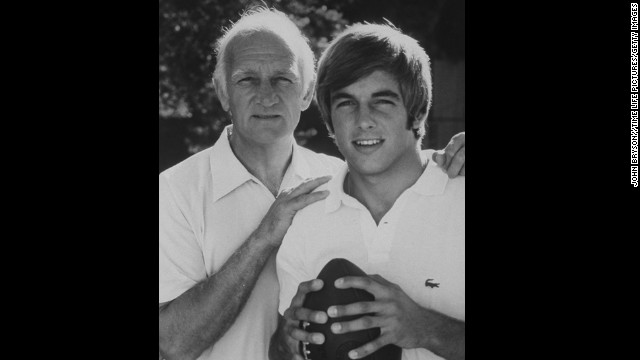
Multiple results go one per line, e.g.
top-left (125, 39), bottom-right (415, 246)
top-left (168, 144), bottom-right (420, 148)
top-left (316, 23), bottom-right (432, 139)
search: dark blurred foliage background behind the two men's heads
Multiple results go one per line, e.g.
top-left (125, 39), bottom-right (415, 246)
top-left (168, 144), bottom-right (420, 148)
top-left (159, 0), bottom-right (464, 171)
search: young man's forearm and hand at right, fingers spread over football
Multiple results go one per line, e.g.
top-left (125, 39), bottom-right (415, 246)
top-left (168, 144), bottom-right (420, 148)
top-left (327, 275), bottom-right (465, 360)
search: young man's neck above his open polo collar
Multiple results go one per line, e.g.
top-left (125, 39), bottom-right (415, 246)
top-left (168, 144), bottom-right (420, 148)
top-left (344, 150), bottom-right (428, 224)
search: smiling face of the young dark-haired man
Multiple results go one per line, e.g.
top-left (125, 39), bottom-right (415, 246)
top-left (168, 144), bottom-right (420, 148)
top-left (330, 70), bottom-right (418, 175)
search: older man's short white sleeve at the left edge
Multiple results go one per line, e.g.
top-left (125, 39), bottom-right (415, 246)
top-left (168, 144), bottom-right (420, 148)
top-left (159, 174), bottom-right (206, 303)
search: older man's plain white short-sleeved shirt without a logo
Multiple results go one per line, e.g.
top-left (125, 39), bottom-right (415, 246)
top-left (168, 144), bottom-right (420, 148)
top-left (159, 126), bottom-right (343, 360)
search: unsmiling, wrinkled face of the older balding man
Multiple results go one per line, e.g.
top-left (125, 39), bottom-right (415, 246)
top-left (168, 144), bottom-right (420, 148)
top-left (227, 32), bottom-right (310, 144)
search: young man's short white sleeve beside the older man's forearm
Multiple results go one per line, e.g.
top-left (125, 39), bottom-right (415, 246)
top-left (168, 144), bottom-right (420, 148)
top-left (276, 217), bottom-right (311, 315)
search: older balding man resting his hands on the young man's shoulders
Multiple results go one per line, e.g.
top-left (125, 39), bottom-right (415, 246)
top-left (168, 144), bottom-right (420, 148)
top-left (159, 8), bottom-right (464, 359)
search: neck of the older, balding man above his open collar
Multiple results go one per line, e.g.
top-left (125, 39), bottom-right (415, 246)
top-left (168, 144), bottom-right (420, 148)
top-left (229, 132), bottom-right (295, 196)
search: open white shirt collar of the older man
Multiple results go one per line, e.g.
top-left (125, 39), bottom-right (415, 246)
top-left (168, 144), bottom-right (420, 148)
top-left (209, 125), bottom-right (311, 202)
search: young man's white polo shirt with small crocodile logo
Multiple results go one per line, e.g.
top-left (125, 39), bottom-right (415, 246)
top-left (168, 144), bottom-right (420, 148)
top-left (276, 151), bottom-right (465, 359)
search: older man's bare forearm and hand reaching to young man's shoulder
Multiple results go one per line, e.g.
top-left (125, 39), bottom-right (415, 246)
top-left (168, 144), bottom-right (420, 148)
top-left (159, 177), bottom-right (329, 359)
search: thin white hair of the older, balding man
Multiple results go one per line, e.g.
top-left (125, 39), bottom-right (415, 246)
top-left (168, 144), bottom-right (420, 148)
top-left (213, 6), bottom-right (315, 102)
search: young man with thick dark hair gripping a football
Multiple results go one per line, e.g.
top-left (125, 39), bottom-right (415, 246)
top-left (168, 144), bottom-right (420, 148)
top-left (270, 24), bottom-right (465, 359)
